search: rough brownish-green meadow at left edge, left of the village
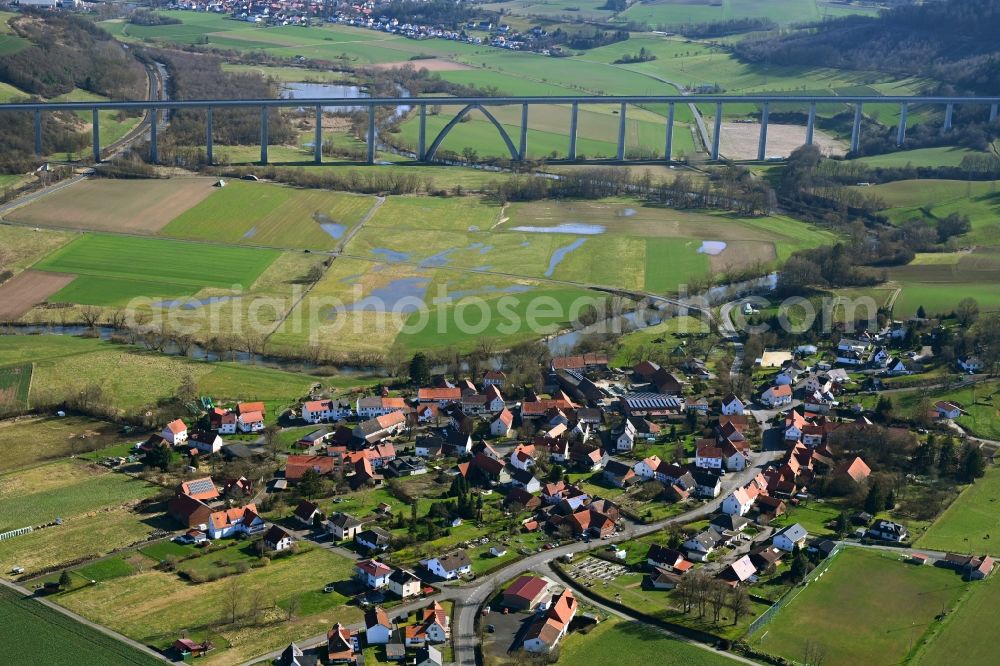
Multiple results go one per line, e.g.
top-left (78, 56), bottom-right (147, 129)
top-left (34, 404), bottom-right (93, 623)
top-left (0, 412), bottom-right (120, 472)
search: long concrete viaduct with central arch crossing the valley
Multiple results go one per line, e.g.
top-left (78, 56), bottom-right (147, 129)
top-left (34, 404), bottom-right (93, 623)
top-left (0, 95), bottom-right (1000, 164)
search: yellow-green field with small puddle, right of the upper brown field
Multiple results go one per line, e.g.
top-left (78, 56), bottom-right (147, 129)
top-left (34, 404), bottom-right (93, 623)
top-left (161, 181), bottom-right (375, 250)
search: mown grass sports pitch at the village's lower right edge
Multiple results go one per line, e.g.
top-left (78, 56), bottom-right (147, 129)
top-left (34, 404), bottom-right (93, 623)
top-left (751, 548), bottom-right (976, 666)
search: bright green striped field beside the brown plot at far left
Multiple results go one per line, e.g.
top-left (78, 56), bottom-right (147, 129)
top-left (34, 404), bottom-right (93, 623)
top-left (34, 234), bottom-right (278, 305)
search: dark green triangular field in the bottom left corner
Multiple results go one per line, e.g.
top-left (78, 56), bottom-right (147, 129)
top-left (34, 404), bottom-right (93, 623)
top-left (0, 587), bottom-right (162, 666)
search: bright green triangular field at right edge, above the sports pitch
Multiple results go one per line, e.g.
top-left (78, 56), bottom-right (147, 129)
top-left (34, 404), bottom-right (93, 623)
top-left (914, 467), bottom-right (1000, 554)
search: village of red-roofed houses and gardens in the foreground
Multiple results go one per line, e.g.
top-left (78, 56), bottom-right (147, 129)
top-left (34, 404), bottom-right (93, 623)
top-left (43, 304), bottom-right (994, 664)
